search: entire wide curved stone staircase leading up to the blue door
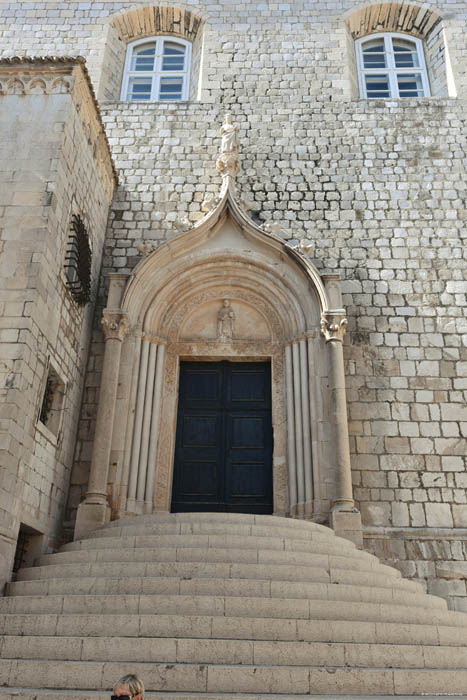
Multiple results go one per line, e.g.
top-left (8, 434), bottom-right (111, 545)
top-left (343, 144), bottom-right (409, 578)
top-left (0, 513), bottom-right (467, 700)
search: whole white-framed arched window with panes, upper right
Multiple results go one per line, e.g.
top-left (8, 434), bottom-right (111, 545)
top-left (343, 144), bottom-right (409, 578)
top-left (355, 34), bottom-right (430, 99)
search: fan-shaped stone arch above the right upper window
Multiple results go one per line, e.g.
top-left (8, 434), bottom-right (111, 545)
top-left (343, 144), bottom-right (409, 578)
top-left (347, 2), bottom-right (441, 39)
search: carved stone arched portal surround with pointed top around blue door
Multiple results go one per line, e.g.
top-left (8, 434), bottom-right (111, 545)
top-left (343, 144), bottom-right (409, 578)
top-left (77, 178), bottom-right (362, 540)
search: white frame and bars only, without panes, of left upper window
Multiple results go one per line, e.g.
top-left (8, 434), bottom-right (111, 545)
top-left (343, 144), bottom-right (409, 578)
top-left (120, 34), bottom-right (192, 103)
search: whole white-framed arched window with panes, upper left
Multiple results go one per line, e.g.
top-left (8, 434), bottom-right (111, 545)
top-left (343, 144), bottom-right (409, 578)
top-left (121, 36), bottom-right (191, 102)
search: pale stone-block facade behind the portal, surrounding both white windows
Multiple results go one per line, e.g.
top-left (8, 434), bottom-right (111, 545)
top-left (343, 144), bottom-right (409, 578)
top-left (1, 0), bottom-right (467, 609)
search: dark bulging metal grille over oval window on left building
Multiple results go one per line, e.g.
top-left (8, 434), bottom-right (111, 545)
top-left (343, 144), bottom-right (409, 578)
top-left (65, 214), bottom-right (91, 306)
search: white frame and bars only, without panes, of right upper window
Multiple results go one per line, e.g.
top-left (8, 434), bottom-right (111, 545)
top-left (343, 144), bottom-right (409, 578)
top-left (355, 32), bottom-right (431, 100)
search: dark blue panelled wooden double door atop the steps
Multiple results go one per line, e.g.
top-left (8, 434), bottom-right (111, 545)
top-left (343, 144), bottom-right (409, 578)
top-left (172, 362), bottom-right (272, 513)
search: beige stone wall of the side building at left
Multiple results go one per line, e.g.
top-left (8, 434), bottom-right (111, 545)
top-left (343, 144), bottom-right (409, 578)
top-left (0, 65), bottom-right (113, 580)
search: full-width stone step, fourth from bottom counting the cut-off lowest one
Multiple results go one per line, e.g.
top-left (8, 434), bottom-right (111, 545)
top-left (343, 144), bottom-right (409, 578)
top-left (0, 613), bottom-right (467, 646)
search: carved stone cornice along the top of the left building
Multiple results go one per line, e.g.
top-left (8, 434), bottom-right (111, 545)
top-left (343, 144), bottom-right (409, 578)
top-left (0, 56), bottom-right (118, 186)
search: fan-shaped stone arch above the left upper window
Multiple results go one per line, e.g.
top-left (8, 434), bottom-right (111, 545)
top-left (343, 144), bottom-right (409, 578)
top-left (111, 6), bottom-right (203, 43)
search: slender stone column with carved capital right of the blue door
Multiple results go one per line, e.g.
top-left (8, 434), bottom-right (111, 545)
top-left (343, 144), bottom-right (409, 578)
top-left (321, 309), bottom-right (362, 546)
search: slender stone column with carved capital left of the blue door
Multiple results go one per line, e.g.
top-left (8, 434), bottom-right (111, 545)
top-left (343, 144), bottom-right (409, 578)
top-left (75, 275), bottom-right (129, 539)
